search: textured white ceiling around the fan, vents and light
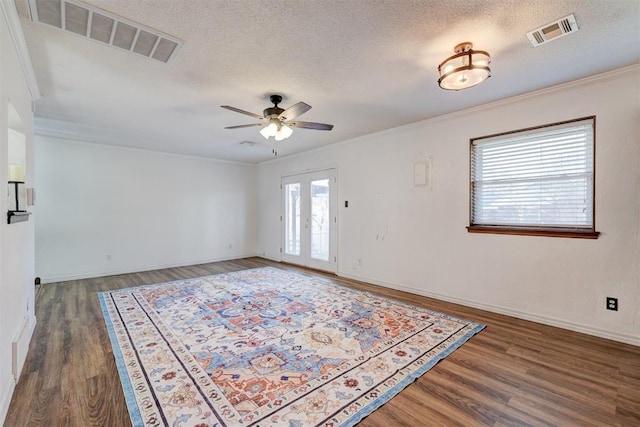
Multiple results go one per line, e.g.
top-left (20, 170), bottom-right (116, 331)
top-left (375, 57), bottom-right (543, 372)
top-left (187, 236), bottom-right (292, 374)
top-left (13, 0), bottom-right (640, 162)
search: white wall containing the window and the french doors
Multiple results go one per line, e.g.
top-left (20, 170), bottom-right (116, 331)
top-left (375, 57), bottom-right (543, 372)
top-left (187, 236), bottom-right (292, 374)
top-left (258, 67), bottom-right (640, 345)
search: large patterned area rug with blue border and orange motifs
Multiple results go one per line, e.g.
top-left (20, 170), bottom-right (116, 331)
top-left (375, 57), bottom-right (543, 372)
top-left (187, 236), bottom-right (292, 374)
top-left (99, 267), bottom-right (484, 427)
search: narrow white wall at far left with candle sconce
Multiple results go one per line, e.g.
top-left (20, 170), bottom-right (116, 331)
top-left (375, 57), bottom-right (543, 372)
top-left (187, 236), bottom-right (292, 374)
top-left (0, 2), bottom-right (36, 424)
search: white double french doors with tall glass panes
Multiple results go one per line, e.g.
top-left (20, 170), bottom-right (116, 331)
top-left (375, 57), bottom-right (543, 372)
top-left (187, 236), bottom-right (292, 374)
top-left (282, 169), bottom-right (338, 273)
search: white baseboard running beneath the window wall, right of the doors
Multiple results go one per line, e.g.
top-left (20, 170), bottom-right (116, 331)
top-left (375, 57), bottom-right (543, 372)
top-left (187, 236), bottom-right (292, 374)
top-left (337, 271), bottom-right (640, 347)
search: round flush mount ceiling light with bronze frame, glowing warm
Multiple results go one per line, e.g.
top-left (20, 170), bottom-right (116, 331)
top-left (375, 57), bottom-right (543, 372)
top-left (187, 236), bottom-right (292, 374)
top-left (438, 42), bottom-right (491, 90)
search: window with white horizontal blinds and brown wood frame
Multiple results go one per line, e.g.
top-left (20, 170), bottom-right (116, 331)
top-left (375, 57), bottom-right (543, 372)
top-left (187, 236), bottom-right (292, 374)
top-left (469, 117), bottom-right (597, 238)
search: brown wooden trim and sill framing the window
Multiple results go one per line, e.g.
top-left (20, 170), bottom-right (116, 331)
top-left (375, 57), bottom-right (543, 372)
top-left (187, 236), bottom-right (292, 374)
top-left (466, 115), bottom-right (600, 239)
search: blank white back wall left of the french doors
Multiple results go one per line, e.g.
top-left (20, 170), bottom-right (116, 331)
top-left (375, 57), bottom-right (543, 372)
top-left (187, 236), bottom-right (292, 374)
top-left (35, 135), bottom-right (257, 283)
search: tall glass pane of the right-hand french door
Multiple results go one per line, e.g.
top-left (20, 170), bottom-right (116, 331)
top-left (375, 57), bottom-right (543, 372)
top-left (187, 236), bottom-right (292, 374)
top-left (311, 179), bottom-right (331, 261)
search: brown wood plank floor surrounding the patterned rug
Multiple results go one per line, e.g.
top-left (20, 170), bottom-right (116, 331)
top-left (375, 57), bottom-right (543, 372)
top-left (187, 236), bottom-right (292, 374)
top-left (5, 258), bottom-right (640, 427)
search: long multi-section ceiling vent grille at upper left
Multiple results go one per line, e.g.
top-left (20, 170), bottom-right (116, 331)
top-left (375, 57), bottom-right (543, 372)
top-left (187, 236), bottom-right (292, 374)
top-left (29, 0), bottom-right (182, 63)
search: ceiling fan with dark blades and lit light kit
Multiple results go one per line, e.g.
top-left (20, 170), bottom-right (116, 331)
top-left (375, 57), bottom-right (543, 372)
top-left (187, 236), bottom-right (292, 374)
top-left (221, 95), bottom-right (333, 145)
